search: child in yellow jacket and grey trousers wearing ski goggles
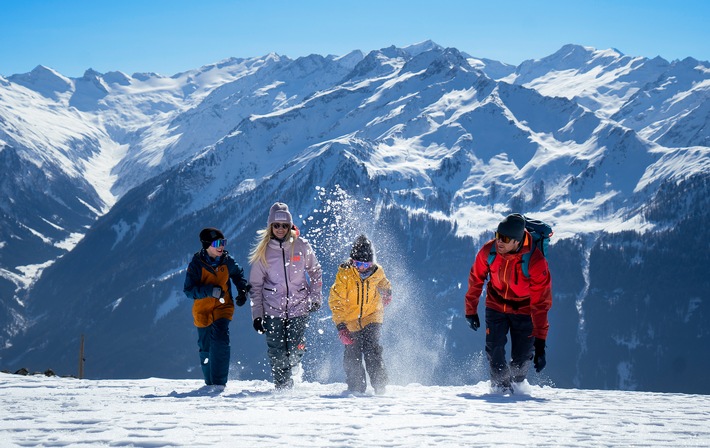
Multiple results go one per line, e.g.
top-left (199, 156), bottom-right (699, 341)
top-left (328, 235), bottom-right (392, 395)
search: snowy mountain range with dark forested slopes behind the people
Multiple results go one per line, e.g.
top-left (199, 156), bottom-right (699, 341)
top-left (0, 42), bottom-right (710, 393)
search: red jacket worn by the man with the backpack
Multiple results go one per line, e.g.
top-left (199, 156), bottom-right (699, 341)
top-left (466, 231), bottom-right (552, 339)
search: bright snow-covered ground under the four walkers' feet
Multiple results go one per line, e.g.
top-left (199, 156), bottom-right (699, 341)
top-left (0, 374), bottom-right (710, 447)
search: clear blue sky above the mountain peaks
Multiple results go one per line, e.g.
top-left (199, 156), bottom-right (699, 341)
top-left (0, 0), bottom-right (710, 77)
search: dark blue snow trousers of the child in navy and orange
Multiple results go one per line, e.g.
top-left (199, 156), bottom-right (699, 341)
top-left (197, 319), bottom-right (231, 385)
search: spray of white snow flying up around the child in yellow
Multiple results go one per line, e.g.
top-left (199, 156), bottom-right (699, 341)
top-left (306, 185), bottom-right (448, 384)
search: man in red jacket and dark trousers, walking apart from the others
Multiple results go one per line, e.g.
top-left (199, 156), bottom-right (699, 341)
top-left (466, 213), bottom-right (552, 392)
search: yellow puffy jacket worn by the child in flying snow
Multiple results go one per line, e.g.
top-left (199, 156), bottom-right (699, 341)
top-left (328, 263), bottom-right (392, 331)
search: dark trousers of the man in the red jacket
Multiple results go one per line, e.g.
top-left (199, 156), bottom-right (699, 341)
top-left (486, 308), bottom-right (534, 387)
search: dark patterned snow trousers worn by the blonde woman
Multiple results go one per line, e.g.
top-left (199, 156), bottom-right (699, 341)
top-left (264, 314), bottom-right (308, 388)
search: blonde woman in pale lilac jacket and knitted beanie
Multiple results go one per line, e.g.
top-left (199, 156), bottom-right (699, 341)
top-left (249, 202), bottom-right (323, 389)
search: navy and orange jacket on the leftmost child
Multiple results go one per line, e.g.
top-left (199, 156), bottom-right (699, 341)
top-left (183, 249), bottom-right (248, 328)
